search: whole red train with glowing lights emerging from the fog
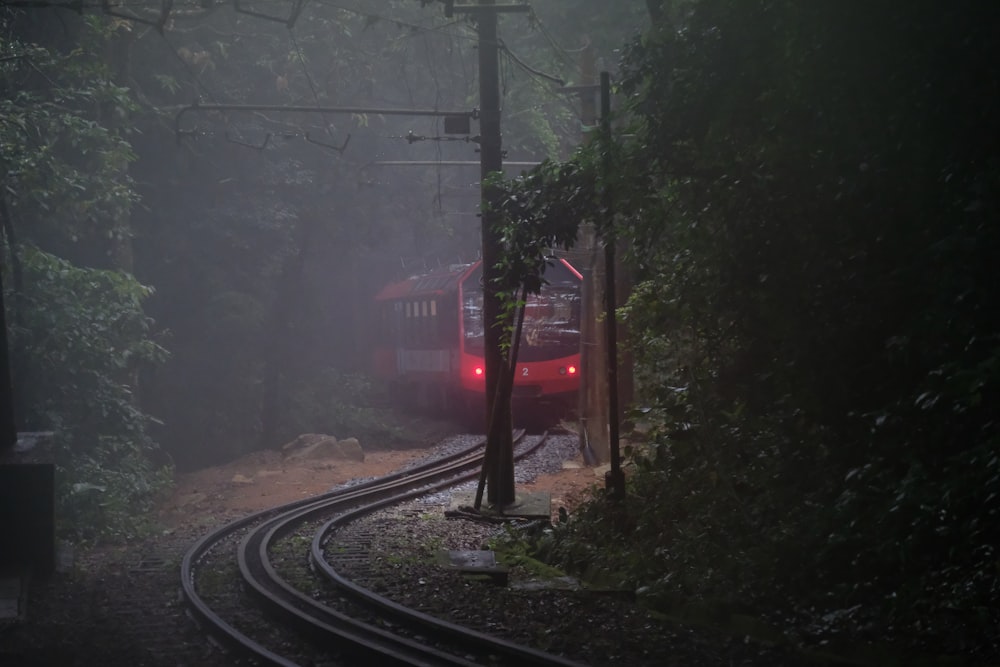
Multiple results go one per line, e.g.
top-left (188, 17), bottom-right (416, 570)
top-left (374, 259), bottom-right (581, 420)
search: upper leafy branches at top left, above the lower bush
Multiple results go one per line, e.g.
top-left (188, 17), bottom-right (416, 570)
top-left (0, 21), bottom-right (136, 262)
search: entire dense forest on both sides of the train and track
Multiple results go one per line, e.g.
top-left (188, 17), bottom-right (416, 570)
top-left (0, 0), bottom-right (1000, 664)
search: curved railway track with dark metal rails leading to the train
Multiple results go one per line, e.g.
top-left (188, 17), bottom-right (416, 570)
top-left (181, 432), bottom-right (578, 667)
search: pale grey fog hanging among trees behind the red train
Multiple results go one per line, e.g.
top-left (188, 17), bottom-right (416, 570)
top-left (0, 0), bottom-right (642, 469)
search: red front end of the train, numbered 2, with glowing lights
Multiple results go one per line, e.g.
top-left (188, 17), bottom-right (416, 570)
top-left (459, 259), bottom-right (581, 421)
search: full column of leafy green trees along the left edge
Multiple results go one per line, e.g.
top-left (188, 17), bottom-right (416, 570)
top-left (0, 15), bottom-right (166, 537)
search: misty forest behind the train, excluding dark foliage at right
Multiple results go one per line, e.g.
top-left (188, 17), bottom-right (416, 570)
top-left (0, 0), bottom-right (646, 533)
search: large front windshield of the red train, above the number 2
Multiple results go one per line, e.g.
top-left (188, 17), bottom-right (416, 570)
top-left (463, 268), bottom-right (580, 362)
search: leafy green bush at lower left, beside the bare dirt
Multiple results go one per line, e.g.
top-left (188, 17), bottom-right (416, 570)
top-left (5, 246), bottom-right (169, 539)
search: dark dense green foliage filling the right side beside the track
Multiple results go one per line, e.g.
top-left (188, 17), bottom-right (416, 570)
top-left (496, 0), bottom-right (1000, 659)
